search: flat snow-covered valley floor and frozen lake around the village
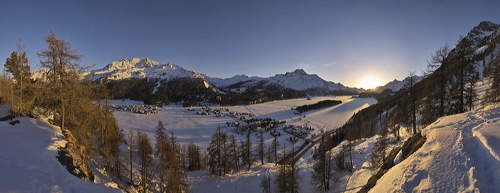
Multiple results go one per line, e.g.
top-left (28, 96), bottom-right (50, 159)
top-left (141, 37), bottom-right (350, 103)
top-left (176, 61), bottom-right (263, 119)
top-left (112, 96), bottom-right (376, 149)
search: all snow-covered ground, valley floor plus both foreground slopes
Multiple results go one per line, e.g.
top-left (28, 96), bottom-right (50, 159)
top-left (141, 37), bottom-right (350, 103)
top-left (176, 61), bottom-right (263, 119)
top-left (0, 84), bottom-right (500, 193)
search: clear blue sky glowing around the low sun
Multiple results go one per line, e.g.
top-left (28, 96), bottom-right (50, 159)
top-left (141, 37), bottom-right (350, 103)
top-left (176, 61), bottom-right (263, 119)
top-left (0, 0), bottom-right (500, 87)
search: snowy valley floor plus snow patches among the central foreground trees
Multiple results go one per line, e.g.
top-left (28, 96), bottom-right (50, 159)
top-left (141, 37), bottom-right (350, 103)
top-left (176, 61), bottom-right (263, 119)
top-left (112, 96), bottom-right (376, 193)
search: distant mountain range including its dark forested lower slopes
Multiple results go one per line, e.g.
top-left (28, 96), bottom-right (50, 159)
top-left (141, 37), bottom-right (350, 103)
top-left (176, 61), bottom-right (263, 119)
top-left (82, 58), bottom-right (360, 105)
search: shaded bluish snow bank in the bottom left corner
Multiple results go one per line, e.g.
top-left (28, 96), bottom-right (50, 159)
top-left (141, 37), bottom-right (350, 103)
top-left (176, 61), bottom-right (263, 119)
top-left (0, 106), bottom-right (121, 193)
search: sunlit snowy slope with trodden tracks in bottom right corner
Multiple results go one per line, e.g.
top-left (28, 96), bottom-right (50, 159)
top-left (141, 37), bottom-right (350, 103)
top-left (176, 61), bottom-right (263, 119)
top-left (371, 108), bottom-right (500, 192)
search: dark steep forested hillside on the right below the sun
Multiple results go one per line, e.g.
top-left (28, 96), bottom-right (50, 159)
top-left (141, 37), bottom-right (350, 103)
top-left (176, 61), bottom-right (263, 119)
top-left (342, 21), bottom-right (500, 142)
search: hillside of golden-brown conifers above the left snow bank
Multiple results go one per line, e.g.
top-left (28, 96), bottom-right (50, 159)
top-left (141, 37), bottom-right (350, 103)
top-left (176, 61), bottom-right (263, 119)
top-left (0, 31), bottom-right (123, 185)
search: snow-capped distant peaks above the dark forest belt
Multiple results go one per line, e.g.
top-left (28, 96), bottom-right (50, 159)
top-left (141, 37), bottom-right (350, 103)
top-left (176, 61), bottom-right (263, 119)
top-left (83, 58), bottom-right (358, 94)
